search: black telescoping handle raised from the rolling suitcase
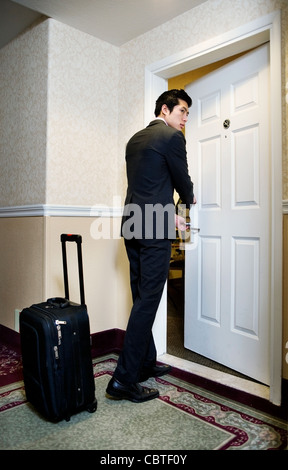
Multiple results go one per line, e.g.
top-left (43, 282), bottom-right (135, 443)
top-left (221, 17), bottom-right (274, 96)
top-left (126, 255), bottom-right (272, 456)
top-left (61, 233), bottom-right (85, 305)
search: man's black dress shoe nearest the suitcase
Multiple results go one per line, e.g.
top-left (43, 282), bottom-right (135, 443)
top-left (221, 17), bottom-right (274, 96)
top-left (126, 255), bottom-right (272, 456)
top-left (106, 377), bottom-right (159, 403)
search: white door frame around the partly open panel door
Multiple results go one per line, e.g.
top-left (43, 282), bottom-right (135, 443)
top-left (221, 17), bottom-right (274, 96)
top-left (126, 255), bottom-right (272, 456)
top-left (145, 11), bottom-right (283, 405)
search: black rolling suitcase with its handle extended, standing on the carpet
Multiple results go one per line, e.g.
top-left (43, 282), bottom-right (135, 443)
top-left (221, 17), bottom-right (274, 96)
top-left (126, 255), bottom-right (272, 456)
top-left (20, 234), bottom-right (97, 422)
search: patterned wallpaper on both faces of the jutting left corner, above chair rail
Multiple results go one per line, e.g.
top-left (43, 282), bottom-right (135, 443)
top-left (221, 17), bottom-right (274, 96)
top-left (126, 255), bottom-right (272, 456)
top-left (0, 19), bottom-right (120, 207)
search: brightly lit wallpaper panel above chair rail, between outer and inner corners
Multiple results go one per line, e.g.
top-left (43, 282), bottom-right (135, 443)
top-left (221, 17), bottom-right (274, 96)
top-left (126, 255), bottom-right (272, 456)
top-left (46, 21), bottom-right (120, 206)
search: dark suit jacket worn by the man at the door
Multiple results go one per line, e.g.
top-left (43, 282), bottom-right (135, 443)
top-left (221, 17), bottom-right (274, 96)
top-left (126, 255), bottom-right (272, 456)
top-left (121, 119), bottom-right (193, 239)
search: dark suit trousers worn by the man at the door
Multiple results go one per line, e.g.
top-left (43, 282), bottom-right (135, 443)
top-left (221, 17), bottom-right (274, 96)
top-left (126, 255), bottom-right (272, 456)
top-left (114, 239), bottom-right (171, 384)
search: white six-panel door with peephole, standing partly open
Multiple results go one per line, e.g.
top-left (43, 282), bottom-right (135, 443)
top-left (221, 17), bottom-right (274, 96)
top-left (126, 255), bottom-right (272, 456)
top-left (184, 45), bottom-right (271, 384)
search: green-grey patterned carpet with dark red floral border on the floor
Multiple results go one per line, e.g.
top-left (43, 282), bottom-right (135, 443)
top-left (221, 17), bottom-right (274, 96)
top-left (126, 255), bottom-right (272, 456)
top-left (0, 350), bottom-right (288, 452)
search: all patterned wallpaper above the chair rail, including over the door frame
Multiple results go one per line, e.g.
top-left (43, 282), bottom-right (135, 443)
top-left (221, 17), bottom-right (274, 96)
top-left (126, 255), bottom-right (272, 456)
top-left (0, 0), bottom-right (288, 207)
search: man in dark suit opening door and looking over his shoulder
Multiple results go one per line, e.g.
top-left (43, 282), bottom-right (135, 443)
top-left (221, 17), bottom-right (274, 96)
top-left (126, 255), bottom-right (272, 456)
top-left (106, 90), bottom-right (196, 403)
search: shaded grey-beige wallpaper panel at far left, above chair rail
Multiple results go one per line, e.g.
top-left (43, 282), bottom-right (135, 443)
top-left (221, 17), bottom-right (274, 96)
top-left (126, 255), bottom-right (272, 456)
top-left (0, 19), bottom-right (48, 206)
